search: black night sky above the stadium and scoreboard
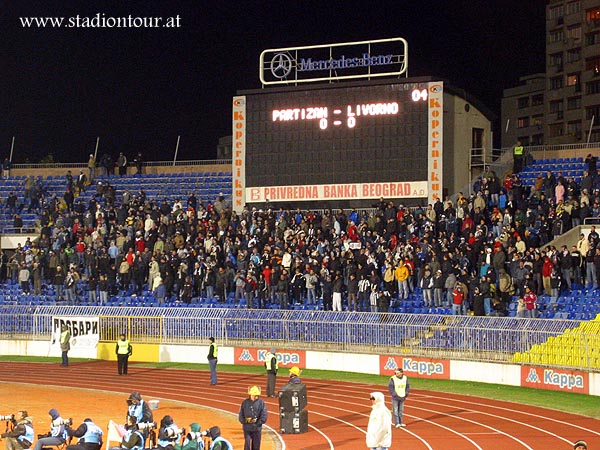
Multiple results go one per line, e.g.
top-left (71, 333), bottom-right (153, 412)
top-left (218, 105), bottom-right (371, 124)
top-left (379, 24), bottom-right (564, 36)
top-left (0, 0), bottom-right (545, 162)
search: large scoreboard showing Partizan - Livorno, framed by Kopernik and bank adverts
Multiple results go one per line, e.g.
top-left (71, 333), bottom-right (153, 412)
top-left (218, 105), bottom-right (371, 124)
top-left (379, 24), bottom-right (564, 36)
top-left (233, 82), bottom-right (443, 209)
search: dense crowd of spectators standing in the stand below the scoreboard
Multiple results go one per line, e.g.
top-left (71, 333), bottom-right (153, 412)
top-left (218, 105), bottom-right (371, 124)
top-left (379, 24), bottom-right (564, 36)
top-left (0, 155), bottom-right (600, 315)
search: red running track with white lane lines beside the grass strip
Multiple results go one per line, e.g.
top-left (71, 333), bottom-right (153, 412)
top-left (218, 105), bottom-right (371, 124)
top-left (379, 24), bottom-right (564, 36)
top-left (0, 361), bottom-right (600, 450)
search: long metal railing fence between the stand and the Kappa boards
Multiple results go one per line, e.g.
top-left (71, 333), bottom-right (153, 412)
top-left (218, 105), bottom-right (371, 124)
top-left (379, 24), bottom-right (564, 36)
top-left (0, 305), bottom-right (600, 371)
